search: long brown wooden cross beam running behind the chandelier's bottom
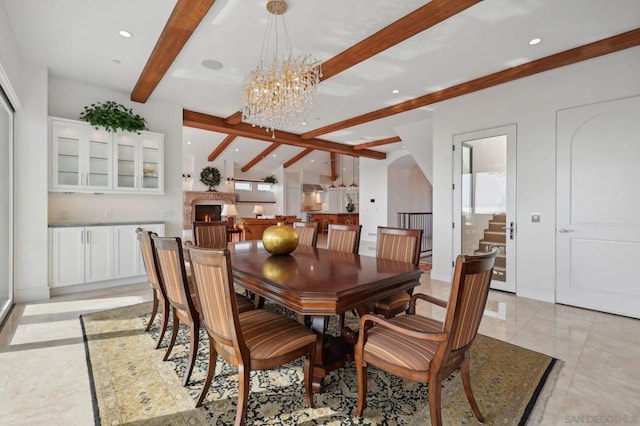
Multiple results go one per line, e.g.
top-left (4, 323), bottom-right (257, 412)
top-left (182, 110), bottom-right (387, 160)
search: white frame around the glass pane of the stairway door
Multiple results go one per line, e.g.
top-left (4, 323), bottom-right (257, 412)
top-left (451, 123), bottom-right (518, 293)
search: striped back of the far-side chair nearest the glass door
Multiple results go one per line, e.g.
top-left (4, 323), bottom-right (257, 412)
top-left (376, 226), bottom-right (422, 265)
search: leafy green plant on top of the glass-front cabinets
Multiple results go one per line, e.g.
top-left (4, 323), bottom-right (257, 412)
top-left (80, 101), bottom-right (147, 134)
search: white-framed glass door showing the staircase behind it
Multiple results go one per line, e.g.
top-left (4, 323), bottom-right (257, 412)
top-left (452, 125), bottom-right (516, 293)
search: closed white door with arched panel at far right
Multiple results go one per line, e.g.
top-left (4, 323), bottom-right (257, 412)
top-left (556, 97), bottom-right (640, 318)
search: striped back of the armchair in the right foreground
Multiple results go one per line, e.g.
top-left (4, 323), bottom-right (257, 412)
top-left (444, 249), bottom-right (497, 352)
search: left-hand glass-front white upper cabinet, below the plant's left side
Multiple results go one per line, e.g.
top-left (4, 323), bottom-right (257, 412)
top-left (49, 118), bottom-right (113, 192)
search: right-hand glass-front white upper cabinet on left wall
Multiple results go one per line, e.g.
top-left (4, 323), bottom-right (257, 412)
top-left (114, 132), bottom-right (164, 193)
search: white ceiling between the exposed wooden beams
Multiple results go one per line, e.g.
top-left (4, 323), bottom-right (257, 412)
top-left (5, 0), bottom-right (640, 174)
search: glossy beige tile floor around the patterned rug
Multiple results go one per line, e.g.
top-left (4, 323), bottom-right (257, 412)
top-left (0, 245), bottom-right (640, 425)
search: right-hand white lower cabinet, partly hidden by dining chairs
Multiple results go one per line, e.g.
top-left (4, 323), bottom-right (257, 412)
top-left (113, 223), bottom-right (164, 278)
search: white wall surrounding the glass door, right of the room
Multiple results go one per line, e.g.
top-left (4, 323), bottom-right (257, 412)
top-left (431, 47), bottom-right (640, 302)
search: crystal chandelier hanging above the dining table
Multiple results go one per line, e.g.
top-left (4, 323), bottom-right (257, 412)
top-left (242, 0), bottom-right (322, 138)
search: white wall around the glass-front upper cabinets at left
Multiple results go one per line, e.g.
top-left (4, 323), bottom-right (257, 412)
top-left (45, 77), bottom-right (182, 236)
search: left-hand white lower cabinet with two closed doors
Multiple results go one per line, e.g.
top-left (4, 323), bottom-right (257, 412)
top-left (51, 226), bottom-right (113, 287)
